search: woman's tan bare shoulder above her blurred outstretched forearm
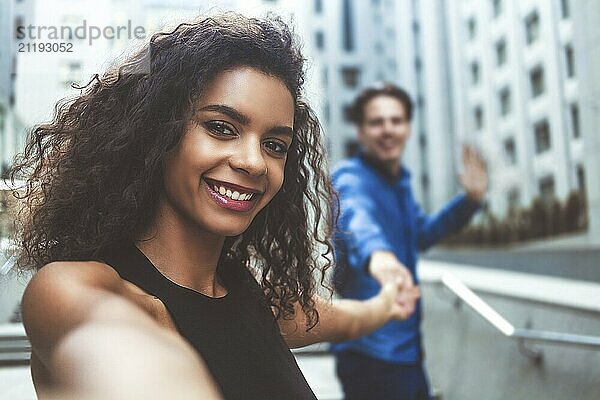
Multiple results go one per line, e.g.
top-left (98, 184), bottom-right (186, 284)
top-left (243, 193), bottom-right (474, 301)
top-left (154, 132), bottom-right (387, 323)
top-left (22, 261), bottom-right (177, 364)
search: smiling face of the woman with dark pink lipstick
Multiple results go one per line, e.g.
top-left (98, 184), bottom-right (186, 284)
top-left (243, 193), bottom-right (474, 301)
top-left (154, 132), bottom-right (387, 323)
top-left (165, 67), bottom-right (294, 236)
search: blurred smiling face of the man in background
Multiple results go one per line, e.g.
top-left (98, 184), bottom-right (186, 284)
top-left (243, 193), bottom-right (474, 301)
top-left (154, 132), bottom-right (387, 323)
top-left (358, 95), bottom-right (410, 165)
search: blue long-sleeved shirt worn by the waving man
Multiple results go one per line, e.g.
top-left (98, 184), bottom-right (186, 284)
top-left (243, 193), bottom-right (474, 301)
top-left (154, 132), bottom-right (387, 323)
top-left (331, 154), bottom-right (479, 364)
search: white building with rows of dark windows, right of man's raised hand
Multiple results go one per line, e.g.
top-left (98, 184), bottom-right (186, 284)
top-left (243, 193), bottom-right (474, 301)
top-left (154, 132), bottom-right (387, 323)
top-left (446, 0), bottom-right (586, 216)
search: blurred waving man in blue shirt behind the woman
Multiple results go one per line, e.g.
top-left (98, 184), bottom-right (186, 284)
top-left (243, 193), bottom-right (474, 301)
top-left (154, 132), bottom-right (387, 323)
top-left (332, 84), bottom-right (487, 400)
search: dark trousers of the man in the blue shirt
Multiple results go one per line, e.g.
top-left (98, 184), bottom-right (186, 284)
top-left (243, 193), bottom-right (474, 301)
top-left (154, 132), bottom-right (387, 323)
top-left (336, 352), bottom-right (430, 400)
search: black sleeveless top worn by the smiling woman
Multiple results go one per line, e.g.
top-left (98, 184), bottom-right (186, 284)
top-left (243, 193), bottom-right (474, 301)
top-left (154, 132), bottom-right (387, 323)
top-left (101, 244), bottom-right (316, 400)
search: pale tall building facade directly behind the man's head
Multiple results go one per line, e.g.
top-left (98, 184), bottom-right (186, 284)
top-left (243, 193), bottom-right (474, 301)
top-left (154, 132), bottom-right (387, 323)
top-left (298, 0), bottom-right (438, 211)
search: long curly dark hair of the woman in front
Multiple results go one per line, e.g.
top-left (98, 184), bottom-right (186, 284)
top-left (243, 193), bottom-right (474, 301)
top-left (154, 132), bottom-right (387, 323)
top-left (11, 13), bottom-right (336, 328)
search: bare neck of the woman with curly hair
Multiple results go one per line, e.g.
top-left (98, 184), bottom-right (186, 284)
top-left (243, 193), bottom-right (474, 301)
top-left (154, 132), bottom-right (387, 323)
top-left (135, 200), bottom-right (227, 297)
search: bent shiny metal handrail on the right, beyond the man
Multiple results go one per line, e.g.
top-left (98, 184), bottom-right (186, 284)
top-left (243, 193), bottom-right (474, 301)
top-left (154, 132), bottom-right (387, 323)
top-left (442, 272), bottom-right (600, 350)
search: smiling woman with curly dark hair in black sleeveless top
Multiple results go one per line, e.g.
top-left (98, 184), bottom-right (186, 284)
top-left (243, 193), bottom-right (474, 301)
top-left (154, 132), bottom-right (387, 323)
top-left (7, 10), bottom-right (418, 399)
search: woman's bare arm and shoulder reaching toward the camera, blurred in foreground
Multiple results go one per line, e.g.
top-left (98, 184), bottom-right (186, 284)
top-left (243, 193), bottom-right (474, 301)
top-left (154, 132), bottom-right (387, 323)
top-left (23, 262), bottom-right (221, 399)
